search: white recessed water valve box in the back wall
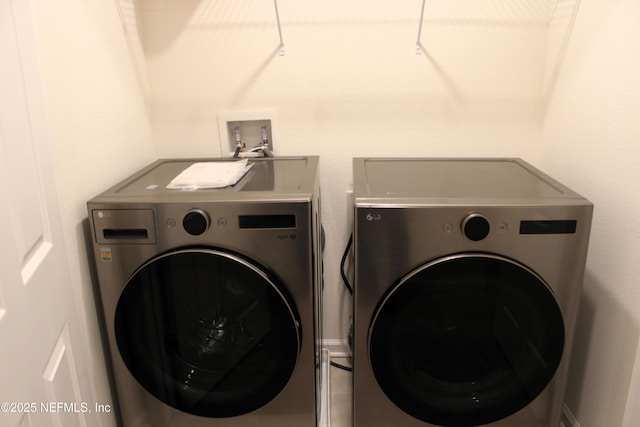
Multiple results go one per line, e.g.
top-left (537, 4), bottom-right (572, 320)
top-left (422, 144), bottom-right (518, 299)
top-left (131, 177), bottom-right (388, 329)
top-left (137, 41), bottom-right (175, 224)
top-left (218, 111), bottom-right (278, 157)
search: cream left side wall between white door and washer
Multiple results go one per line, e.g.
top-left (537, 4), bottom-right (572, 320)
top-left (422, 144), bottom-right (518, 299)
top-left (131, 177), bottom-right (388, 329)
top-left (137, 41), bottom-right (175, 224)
top-left (34, 0), bottom-right (155, 426)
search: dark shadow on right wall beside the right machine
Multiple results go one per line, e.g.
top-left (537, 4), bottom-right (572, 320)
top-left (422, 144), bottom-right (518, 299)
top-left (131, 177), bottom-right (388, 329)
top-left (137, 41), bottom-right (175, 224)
top-left (565, 270), bottom-right (640, 427)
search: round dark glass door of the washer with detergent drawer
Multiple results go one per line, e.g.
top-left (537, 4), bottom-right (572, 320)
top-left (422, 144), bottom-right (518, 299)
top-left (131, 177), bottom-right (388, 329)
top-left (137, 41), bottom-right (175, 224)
top-left (114, 249), bottom-right (301, 418)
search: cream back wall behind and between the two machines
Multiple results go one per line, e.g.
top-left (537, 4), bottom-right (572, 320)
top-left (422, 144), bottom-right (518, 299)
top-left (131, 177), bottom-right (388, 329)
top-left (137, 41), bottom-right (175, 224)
top-left (138, 0), bottom-right (549, 352)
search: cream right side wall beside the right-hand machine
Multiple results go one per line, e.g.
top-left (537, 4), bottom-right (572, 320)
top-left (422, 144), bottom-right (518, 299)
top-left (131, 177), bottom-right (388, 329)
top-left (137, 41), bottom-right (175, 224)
top-left (540, 0), bottom-right (640, 427)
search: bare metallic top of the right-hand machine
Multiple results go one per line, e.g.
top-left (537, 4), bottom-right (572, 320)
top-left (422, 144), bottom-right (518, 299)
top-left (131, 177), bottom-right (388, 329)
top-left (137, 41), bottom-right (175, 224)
top-left (353, 158), bottom-right (586, 206)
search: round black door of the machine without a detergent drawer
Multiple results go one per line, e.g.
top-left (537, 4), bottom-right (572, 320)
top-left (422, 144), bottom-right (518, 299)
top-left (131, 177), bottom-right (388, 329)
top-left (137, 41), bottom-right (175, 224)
top-left (369, 253), bottom-right (564, 427)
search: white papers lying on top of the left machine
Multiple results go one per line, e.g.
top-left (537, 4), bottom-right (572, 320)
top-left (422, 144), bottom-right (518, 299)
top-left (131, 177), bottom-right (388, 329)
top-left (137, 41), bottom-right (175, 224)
top-left (167, 159), bottom-right (253, 190)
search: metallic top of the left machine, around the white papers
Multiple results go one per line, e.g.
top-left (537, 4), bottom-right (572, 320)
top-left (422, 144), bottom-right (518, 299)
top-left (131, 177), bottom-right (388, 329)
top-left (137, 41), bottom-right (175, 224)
top-left (91, 156), bottom-right (319, 203)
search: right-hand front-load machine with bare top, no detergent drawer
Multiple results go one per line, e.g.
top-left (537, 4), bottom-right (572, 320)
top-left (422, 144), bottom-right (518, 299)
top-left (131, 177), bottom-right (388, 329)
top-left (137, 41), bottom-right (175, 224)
top-left (353, 158), bottom-right (593, 427)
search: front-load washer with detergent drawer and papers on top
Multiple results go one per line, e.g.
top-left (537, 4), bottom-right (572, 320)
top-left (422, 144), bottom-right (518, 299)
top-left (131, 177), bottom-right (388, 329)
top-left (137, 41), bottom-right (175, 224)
top-left (88, 157), bottom-right (322, 427)
